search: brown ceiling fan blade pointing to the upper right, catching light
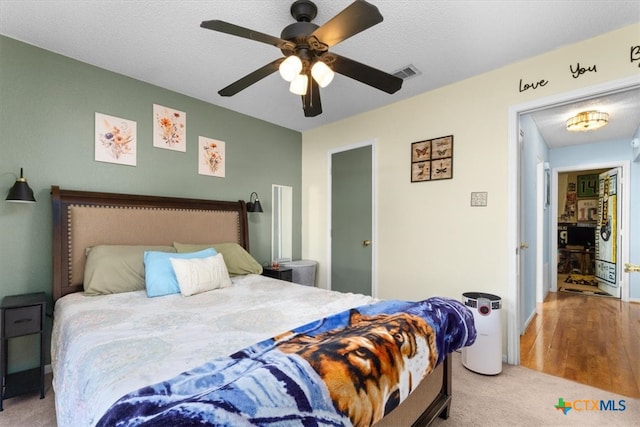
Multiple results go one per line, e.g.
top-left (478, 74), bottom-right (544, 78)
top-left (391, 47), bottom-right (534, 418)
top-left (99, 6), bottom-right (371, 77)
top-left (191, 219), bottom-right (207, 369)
top-left (311, 0), bottom-right (383, 47)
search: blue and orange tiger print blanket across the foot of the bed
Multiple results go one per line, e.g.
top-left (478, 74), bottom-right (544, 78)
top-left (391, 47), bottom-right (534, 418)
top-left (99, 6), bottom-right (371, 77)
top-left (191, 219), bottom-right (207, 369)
top-left (98, 298), bottom-right (476, 427)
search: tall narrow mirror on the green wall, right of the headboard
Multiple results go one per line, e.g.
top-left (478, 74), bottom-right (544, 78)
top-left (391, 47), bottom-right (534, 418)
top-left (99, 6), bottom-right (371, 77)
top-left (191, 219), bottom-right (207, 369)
top-left (271, 184), bottom-right (293, 262)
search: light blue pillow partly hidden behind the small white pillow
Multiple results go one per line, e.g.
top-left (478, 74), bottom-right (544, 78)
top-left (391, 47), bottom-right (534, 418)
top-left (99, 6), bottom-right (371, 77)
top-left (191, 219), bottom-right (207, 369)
top-left (144, 248), bottom-right (218, 297)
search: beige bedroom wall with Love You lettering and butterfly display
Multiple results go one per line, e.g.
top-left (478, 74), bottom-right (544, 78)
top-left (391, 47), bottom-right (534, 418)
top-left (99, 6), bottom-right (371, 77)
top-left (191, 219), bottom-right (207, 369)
top-left (302, 24), bottom-right (640, 299)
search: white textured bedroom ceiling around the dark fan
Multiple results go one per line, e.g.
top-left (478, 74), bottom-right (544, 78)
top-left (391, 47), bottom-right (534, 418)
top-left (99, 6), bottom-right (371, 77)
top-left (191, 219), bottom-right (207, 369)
top-left (0, 0), bottom-right (640, 144)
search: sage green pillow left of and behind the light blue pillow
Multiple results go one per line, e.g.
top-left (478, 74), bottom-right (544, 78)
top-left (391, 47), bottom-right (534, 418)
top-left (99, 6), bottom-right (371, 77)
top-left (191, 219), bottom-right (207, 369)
top-left (84, 245), bottom-right (176, 295)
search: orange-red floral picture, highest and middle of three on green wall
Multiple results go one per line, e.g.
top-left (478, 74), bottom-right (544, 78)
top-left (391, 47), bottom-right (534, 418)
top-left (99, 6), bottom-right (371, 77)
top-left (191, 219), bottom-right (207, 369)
top-left (153, 104), bottom-right (187, 152)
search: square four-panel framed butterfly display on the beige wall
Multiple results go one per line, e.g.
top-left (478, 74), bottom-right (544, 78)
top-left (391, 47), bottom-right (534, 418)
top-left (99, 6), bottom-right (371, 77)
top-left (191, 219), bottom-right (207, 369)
top-left (411, 135), bottom-right (453, 182)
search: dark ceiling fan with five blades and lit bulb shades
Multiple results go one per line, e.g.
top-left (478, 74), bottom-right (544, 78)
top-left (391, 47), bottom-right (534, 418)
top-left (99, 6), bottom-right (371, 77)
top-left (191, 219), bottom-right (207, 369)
top-left (200, 0), bottom-right (402, 117)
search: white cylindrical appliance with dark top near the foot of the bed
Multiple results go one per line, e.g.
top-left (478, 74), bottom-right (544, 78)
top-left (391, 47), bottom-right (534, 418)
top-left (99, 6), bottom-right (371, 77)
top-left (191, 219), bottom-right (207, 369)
top-left (462, 292), bottom-right (502, 375)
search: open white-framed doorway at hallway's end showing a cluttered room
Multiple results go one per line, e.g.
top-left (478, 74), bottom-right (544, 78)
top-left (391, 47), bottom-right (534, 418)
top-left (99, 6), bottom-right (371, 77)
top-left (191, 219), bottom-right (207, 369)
top-left (539, 162), bottom-right (633, 302)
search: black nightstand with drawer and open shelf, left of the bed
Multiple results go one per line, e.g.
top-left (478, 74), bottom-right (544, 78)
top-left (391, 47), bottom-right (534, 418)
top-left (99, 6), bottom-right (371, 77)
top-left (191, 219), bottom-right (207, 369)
top-left (0, 292), bottom-right (46, 411)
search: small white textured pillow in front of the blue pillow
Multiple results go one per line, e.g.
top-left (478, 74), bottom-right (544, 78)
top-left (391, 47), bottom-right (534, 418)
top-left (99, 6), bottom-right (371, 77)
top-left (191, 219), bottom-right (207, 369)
top-left (169, 254), bottom-right (231, 297)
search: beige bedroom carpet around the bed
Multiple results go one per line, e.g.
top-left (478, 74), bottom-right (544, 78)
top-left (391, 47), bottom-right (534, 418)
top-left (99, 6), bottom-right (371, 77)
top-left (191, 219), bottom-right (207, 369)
top-left (0, 353), bottom-right (640, 427)
